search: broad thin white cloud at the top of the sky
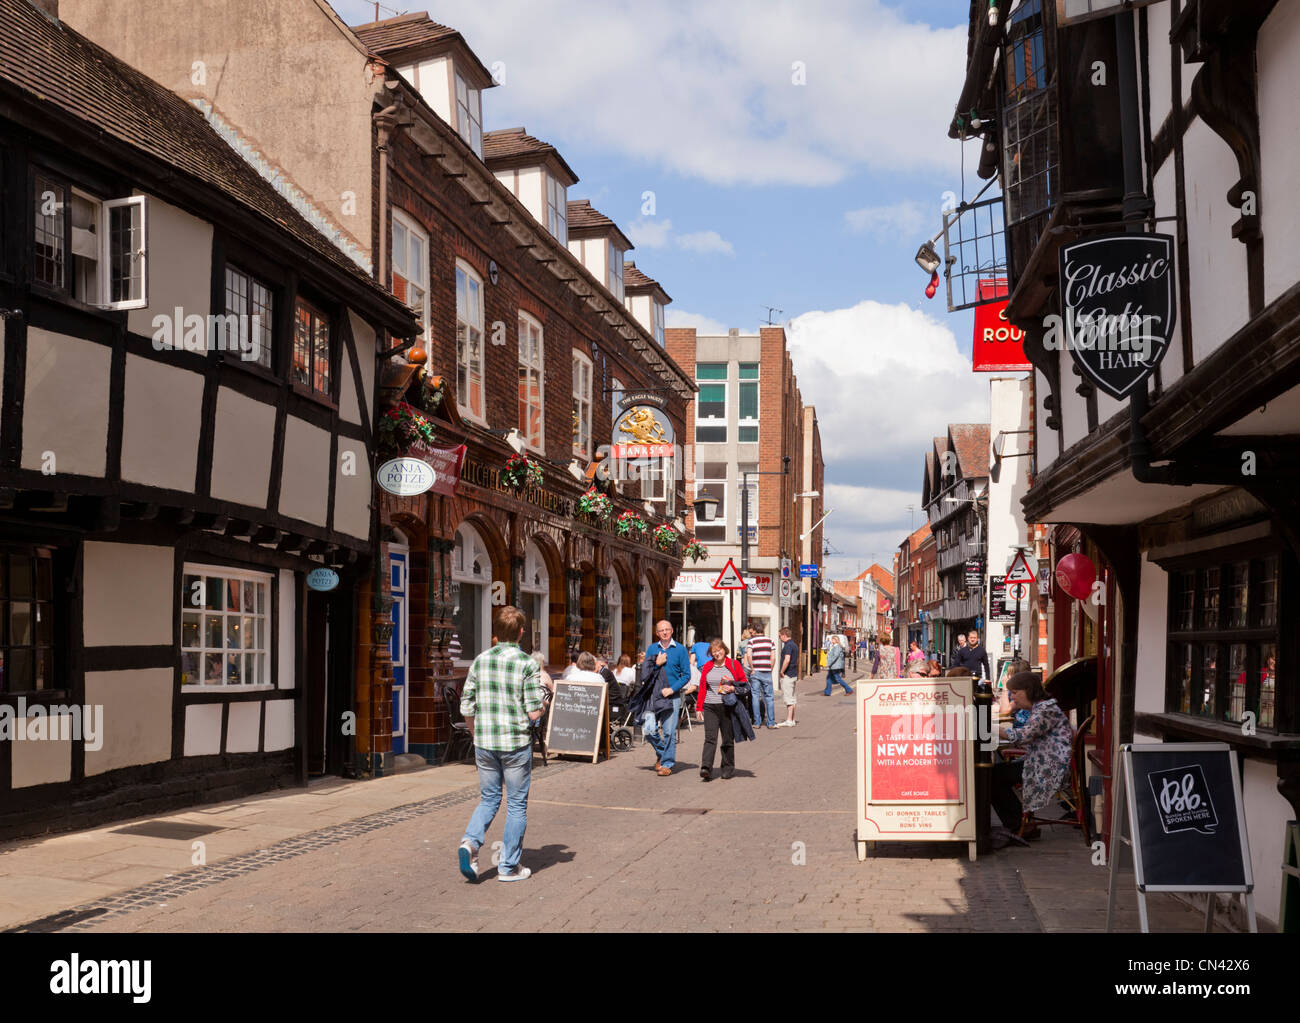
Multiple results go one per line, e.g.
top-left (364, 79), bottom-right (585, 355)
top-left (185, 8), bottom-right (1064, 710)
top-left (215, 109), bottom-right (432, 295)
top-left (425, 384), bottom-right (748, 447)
top-left (356, 0), bottom-right (966, 187)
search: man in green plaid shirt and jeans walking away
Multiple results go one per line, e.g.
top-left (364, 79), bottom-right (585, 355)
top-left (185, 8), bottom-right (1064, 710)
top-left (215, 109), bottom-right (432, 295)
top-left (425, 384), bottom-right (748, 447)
top-left (456, 607), bottom-right (545, 881)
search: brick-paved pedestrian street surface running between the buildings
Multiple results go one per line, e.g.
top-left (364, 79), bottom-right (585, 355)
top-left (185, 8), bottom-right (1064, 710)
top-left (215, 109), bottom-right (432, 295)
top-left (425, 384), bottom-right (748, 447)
top-left (0, 675), bottom-right (1199, 932)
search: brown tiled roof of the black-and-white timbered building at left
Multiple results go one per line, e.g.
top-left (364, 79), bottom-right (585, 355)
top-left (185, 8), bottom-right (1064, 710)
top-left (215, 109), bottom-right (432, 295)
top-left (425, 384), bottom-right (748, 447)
top-left (0, 0), bottom-right (397, 315)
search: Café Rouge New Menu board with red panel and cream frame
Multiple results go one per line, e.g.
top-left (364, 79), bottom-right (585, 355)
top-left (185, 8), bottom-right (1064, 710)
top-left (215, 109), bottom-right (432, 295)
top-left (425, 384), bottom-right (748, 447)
top-left (857, 677), bottom-right (979, 858)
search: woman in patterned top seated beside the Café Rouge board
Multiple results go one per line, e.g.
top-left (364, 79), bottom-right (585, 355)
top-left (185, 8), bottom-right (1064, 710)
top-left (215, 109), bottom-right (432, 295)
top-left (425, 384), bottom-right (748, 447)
top-left (993, 671), bottom-right (1074, 838)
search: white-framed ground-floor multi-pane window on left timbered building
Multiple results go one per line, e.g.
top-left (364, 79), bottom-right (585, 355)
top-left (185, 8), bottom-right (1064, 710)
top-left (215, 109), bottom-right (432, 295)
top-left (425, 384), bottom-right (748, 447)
top-left (178, 564), bottom-right (276, 692)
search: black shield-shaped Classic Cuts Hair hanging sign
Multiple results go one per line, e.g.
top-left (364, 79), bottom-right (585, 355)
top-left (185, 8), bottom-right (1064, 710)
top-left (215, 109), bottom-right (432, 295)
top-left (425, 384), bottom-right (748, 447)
top-left (1043, 234), bottom-right (1175, 399)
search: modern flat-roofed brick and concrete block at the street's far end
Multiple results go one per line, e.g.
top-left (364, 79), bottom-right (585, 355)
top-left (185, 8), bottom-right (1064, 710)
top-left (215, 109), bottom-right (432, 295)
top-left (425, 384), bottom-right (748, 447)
top-left (660, 323), bottom-right (824, 646)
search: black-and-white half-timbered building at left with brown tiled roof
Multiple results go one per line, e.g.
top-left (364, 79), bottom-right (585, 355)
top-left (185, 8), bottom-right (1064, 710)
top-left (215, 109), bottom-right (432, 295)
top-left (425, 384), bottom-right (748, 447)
top-left (0, 0), bottom-right (416, 836)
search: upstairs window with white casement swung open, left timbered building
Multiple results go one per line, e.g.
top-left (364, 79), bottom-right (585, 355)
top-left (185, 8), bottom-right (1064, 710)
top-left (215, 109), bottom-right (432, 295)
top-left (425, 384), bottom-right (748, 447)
top-left (31, 173), bottom-right (148, 309)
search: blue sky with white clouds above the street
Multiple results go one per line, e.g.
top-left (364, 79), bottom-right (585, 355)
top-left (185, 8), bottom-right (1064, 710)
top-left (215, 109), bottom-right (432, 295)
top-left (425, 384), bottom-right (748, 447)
top-left (334, 0), bottom-right (988, 578)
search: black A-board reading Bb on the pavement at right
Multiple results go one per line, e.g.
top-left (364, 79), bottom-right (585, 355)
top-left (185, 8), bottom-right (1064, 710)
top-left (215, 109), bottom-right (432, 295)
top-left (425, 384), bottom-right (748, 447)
top-left (1121, 742), bottom-right (1255, 892)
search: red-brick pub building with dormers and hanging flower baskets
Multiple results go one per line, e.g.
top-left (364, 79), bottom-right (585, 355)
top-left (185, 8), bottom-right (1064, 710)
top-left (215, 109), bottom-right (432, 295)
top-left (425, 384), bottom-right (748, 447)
top-left (62, 0), bottom-right (693, 773)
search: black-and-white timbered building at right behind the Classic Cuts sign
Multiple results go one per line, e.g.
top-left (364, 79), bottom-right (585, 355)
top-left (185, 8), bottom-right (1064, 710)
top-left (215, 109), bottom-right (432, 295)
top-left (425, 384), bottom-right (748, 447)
top-left (952, 0), bottom-right (1300, 930)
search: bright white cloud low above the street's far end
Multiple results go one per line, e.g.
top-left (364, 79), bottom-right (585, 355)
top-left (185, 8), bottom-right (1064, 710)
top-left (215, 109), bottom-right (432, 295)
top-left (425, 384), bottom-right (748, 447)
top-left (787, 302), bottom-right (988, 465)
